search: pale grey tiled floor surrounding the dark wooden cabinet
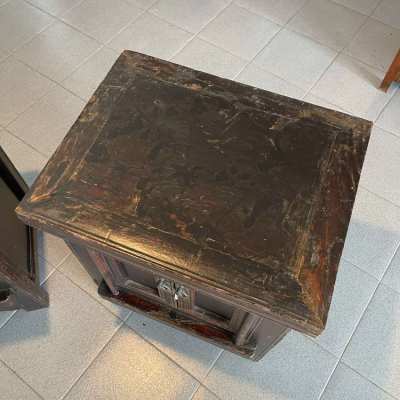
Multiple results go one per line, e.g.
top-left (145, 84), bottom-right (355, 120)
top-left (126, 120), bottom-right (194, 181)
top-left (0, 0), bottom-right (400, 400)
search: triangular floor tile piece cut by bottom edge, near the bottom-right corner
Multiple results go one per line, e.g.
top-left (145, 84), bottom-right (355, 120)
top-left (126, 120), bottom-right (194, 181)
top-left (321, 363), bottom-right (393, 400)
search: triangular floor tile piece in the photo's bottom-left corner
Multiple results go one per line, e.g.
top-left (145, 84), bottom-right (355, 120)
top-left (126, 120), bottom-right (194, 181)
top-left (0, 362), bottom-right (40, 400)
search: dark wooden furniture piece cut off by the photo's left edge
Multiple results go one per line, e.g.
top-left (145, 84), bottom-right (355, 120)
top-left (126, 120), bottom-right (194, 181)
top-left (0, 148), bottom-right (48, 311)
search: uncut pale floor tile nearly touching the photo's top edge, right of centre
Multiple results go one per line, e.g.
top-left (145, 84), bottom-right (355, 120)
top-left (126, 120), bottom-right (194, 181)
top-left (200, 4), bottom-right (280, 60)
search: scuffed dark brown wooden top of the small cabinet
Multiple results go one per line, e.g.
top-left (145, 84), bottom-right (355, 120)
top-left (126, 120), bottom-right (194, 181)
top-left (17, 51), bottom-right (371, 335)
